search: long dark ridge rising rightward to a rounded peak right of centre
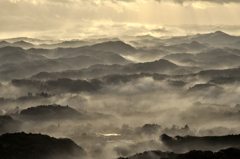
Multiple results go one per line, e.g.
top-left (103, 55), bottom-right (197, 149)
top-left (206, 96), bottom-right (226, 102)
top-left (32, 59), bottom-right (181, 79)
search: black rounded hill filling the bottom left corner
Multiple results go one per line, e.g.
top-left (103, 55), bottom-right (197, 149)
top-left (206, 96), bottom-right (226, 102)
top-left (0, 132), bottom-right (86, 159)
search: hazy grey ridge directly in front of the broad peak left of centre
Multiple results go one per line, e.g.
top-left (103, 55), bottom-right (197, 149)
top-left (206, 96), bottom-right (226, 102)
top-left (26, 46), bottom-right (130, 65)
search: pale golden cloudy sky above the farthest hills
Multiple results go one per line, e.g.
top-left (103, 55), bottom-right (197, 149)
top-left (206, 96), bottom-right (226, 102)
top-left (0, 0), bottom-right (240, 39)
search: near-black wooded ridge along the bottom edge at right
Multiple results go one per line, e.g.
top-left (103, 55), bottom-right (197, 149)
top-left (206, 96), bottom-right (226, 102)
top-left (119, 148), bottom-right (240, 159)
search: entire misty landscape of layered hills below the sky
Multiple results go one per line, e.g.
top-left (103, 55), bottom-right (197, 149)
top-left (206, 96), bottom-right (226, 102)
top-left (0, 31), bottom-right (240, 159)
